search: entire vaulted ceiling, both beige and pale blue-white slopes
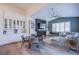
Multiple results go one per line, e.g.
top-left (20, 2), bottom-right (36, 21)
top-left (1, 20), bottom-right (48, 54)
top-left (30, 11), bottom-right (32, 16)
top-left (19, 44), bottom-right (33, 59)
top-left (2, 3), bottom-right (79, 20)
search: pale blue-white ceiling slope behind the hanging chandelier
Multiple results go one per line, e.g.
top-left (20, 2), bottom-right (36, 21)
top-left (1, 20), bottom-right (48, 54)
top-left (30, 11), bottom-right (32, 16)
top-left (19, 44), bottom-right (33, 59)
top-left (31, 3), bottom-right (79, 21)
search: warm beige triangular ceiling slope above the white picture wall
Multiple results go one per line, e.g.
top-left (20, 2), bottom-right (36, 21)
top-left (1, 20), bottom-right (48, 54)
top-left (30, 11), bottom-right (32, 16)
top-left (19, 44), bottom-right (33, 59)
top-left (9, 3), bottom-right (47, 16)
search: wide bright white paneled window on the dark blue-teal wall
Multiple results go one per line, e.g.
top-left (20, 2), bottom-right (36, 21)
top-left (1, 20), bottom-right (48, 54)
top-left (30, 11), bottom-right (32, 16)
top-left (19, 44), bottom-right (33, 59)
top-left (52, 22), bottom-right (70, 32)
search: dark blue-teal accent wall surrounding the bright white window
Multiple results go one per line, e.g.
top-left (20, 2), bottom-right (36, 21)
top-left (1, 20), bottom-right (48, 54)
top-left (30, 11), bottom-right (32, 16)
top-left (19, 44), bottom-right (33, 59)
top-left (48, 17), bottom-right (79, 32)
